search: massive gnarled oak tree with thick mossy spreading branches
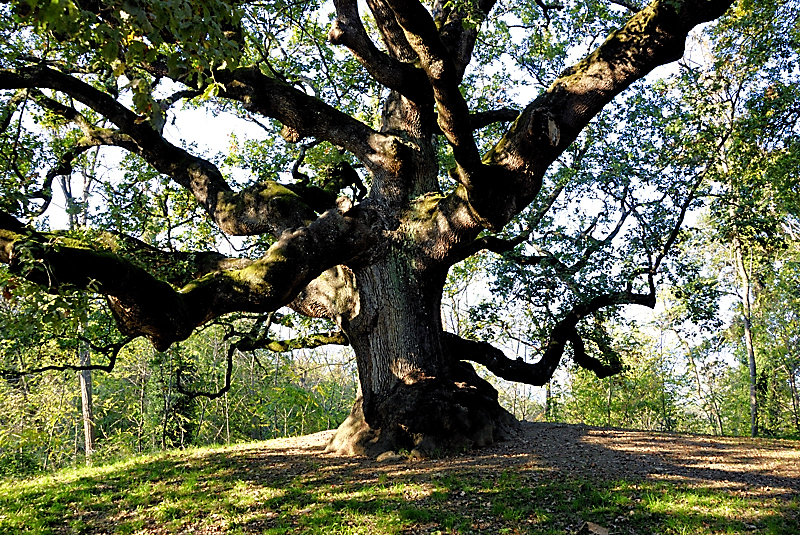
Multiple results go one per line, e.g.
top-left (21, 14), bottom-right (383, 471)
top-left (0, 0), bottom-right (733, 455)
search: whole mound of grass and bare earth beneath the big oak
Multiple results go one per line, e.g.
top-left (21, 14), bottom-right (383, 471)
top-left (0, 424), bottom-right (800, 535)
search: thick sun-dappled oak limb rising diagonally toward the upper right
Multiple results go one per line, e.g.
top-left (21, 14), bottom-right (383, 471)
top-left (468, 0), bottom-right (733, 229)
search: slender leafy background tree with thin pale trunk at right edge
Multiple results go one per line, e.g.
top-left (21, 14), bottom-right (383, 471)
top-left (686, 2), bottom-right (798, 436)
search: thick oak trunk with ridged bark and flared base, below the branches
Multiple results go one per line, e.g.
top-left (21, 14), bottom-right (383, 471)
top-left (328, 247), bottom-right (517, 457)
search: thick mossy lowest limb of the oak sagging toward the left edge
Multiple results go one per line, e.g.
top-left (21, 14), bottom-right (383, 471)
top-left (0, 205), bottom-right (384, 350)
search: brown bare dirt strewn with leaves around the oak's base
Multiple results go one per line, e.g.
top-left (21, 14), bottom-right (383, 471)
top-left (260, 422), bottom-right (800, 497)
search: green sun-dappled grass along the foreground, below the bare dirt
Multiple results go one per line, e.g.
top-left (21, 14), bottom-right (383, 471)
top-left (0, 444), bottom-right (800, 535)
